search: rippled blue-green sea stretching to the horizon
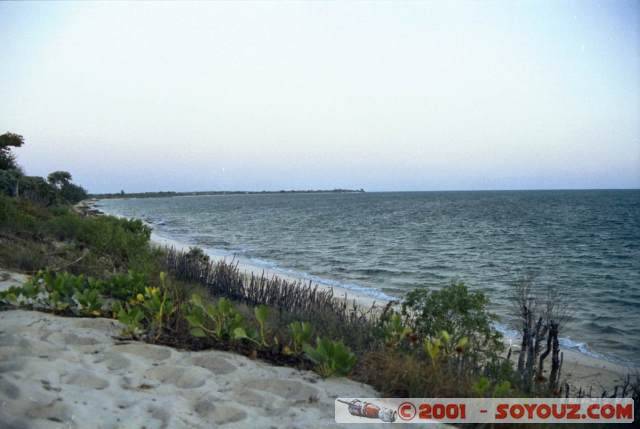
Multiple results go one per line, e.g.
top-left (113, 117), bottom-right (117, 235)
top-left (98, 190), bottom-right (640, 365)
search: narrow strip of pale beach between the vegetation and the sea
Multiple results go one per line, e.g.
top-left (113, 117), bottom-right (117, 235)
top-left (92, 200), bottom-right (640, 394)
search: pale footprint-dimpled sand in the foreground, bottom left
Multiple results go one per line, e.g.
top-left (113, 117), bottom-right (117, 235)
top-left (0, 310), bottom-right (384, 428)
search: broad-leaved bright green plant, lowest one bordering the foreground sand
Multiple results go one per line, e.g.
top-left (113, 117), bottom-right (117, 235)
top-left (303, 337), bottom-right (357, 377)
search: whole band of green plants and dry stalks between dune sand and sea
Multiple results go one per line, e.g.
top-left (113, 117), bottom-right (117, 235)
top-left (0, 133), bottom-right (640, 424)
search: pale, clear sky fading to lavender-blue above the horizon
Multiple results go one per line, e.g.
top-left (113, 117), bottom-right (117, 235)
top-left (0, 0), bottom-right (640, 192)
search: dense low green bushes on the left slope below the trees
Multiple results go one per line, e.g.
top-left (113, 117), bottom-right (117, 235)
top-left (0, 195), bottom-right (161, 277)
